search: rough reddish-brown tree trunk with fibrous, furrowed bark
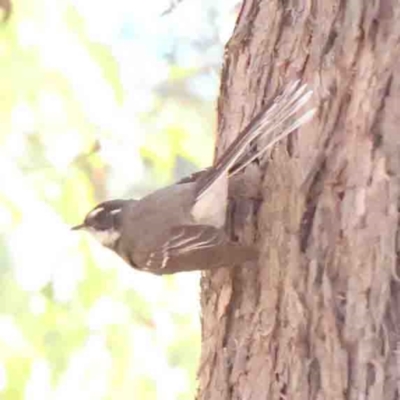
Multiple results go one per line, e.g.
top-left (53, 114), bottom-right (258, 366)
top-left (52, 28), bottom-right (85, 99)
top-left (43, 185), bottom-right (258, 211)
top-left (198, 0), bottom-right (400, 400)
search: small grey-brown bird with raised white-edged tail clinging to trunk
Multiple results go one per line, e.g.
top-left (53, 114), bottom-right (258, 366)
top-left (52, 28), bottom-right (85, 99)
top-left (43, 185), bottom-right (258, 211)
top-left (73, 81), bottom-right (314, 275)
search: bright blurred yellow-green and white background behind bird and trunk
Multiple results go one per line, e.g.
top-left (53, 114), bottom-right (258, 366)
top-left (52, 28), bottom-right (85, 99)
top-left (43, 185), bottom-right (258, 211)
top-left (0, 0), bottom-right (238, 400)
